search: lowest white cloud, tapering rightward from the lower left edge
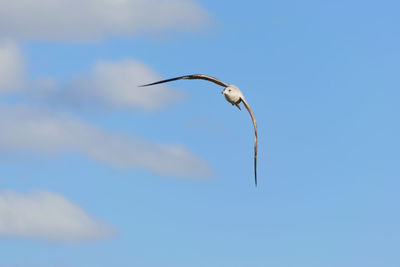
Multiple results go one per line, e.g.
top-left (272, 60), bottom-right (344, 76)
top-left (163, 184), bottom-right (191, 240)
top-left (0, 191), bottom-right (115, 242)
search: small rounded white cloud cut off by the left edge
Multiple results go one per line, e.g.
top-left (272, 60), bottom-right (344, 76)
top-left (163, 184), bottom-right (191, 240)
top-left (0, 41), bottom-right (26, 94)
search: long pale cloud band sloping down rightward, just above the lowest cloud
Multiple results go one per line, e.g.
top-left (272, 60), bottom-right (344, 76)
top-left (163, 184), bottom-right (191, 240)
top-left (0, 106), bottom-right (211, 177)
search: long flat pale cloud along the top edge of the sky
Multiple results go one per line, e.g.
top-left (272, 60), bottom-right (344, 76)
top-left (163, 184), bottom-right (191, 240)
top-left (0, 0), bottom-right (208, 41)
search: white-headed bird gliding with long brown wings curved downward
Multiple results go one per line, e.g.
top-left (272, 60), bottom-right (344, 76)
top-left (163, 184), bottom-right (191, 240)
top-left (139, 74), bottom-right (257, 186)
